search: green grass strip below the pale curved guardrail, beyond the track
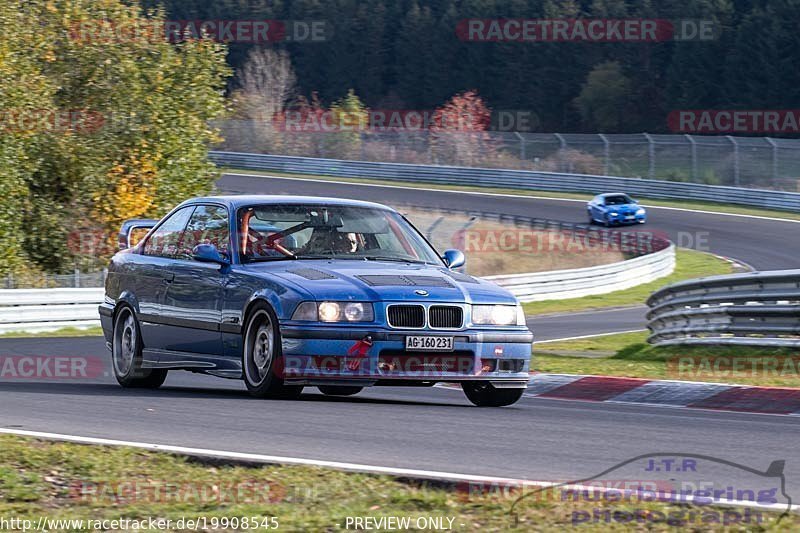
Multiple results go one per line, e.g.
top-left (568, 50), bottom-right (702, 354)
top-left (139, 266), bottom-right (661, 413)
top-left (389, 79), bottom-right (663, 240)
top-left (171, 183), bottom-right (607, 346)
top-left (523, 249), bottom-right (733, 315)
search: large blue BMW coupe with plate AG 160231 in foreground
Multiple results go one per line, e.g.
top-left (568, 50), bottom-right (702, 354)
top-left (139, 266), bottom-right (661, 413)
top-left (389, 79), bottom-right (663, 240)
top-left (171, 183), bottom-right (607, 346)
top-left (100, 196), bottom-right (533, 406)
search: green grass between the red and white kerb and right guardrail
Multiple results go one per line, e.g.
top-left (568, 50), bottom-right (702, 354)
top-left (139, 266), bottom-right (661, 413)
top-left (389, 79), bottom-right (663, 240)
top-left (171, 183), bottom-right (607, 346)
top-left (533, 331), bottom-right (800, 387)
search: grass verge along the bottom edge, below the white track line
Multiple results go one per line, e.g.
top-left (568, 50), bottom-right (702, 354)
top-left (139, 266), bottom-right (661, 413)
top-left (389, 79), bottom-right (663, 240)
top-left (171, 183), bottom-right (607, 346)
top-left (0, 436), bottom-right (800, 532)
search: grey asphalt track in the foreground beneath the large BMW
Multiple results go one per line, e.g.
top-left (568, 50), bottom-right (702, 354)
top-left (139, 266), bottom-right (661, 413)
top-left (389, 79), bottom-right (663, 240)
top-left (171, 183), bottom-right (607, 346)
top-left (0, 337), bottom-right (800, 501)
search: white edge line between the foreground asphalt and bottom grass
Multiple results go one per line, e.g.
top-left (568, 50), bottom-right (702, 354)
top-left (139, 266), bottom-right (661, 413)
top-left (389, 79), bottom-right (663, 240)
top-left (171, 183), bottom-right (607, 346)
top-left (0, 428), bottom-right (800, 511)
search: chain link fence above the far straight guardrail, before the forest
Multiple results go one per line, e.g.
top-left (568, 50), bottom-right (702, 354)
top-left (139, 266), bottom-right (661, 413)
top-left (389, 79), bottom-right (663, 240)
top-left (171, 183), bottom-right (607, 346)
top-left (215, 120), bottom-right (800, 192)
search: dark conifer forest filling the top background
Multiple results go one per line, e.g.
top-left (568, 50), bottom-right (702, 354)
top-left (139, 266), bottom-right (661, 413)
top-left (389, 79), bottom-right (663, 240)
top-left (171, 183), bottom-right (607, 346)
top-left (144, 0), bottom-right (800, 133)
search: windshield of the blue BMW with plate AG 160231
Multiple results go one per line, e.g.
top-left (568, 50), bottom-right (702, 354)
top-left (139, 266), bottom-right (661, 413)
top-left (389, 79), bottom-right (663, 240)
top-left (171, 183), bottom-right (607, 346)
top-left (239, 204), bottom-right (443, 265)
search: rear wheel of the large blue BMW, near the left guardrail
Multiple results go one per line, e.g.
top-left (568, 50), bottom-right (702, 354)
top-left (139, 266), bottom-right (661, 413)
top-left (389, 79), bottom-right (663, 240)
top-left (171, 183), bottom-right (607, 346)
top-left (111, 305), bottom-right (167, 389)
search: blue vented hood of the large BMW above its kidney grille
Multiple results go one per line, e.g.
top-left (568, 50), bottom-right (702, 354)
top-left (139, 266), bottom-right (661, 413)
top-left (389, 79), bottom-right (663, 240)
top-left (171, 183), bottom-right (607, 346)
top-left (245, 260), bottom-right (516, 304)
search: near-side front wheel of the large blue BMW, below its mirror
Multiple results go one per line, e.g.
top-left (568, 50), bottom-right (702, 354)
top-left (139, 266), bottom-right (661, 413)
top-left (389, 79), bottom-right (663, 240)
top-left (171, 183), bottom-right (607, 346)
top-left (242, 302), bottom-right (303, 399)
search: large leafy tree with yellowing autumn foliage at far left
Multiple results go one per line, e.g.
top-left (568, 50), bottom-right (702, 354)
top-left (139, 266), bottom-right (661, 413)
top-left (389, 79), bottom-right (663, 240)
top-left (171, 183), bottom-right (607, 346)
top-left (0, 0), bottom-right (230, 272)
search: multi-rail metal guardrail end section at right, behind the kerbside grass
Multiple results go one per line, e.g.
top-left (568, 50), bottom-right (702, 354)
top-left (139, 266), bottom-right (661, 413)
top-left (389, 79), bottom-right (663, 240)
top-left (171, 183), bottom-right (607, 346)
top-left (647, 270), bottom-right (800, 347)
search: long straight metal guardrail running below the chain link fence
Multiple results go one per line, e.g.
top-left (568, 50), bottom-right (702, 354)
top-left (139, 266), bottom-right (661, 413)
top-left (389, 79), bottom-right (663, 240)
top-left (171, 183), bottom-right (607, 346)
top-left (210, 152), bottom-right (800, 211)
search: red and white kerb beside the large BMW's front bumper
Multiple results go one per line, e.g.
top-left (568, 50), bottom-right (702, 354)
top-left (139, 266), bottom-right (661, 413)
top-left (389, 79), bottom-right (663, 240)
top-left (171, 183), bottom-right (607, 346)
top-left (525, 373), bottom-right (800, 416)
